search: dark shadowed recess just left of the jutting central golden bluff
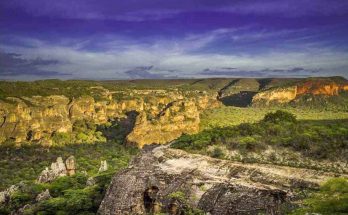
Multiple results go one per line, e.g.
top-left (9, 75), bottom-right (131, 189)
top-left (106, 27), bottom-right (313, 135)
top-left (98, 111), bottom-right (139, 143)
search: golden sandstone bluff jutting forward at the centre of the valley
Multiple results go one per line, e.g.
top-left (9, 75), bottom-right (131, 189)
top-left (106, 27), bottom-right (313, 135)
top-left (127, 97), bottom-right (217, 148)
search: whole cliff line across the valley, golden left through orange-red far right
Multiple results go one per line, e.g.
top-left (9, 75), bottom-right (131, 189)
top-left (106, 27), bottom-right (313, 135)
top-left (0, 78), bottom-right (348, 148)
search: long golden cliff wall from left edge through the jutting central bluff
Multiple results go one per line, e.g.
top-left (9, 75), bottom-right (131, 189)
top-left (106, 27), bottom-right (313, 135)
top-left (0, 86), bottom-right (217, 147)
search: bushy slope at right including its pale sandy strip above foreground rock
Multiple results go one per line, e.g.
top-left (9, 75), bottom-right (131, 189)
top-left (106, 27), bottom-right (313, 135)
top-left (172, 111), bottom-right (348, 172)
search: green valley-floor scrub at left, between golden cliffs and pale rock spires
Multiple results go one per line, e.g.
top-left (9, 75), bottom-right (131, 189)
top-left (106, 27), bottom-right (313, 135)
top-left (0, 142), bottom-right (137, 190)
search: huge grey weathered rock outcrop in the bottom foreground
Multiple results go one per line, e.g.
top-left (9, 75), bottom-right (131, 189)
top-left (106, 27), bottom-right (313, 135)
top-left (98, 146), bottom-right (346, 215)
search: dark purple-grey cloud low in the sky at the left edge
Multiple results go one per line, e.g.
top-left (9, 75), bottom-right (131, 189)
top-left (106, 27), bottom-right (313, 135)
top-left (0, 52), bottom-right (69, 76)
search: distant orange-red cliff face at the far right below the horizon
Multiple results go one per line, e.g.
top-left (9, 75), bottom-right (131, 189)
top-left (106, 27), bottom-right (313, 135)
top-left (252, 79), bottom-right (348, 105)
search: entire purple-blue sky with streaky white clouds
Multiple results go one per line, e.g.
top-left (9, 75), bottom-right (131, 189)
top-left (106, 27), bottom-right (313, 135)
top-left (0, 0), bottom-right (348, 80)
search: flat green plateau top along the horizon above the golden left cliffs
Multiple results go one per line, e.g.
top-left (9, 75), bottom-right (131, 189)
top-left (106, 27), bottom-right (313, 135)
top-left (0, 78), bottom-right (234, 99)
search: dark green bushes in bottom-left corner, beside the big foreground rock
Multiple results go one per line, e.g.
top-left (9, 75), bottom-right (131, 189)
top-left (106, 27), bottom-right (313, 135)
top-left (0, 170), bottom-right (115, 215)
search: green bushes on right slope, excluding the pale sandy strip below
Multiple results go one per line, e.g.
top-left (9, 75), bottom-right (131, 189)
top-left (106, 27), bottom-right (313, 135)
top-left (172, 111), bottom-right (348, 168)
